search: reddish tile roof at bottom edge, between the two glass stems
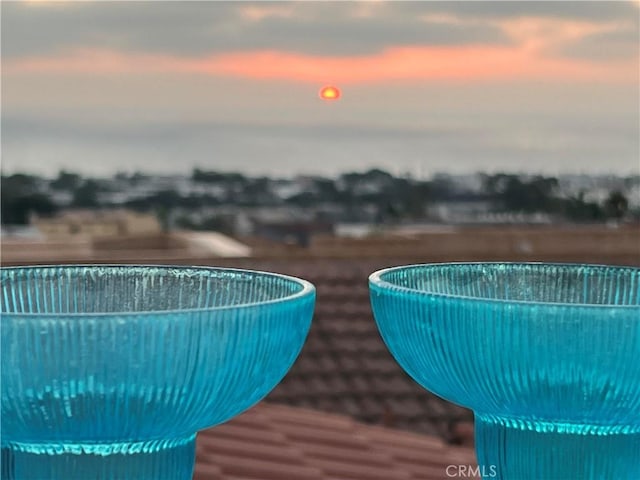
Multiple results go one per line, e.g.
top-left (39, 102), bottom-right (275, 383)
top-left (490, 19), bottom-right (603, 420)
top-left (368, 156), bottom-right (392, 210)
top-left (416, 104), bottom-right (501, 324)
top-left (194, 403), bottom-right (475, 480)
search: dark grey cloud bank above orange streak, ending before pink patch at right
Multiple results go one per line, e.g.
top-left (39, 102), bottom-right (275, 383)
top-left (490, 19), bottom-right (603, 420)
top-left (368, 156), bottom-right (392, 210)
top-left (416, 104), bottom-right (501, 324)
top-left (2, 2), bottom-right (507, 58)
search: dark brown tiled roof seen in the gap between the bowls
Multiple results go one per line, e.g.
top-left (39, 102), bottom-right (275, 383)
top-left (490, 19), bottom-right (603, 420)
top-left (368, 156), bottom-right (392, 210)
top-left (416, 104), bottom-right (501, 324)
top-left (260, 259), bottom-right (472, 443)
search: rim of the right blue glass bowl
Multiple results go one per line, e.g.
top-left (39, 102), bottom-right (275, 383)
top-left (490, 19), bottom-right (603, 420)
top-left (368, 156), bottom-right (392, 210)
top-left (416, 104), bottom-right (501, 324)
top-left (369, 261), bottom-right (640, 310)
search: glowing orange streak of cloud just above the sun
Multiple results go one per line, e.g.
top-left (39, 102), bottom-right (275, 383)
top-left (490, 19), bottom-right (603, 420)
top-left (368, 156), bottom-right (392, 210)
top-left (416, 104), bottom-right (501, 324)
top-left (3, 45), bottom-right (637, 85)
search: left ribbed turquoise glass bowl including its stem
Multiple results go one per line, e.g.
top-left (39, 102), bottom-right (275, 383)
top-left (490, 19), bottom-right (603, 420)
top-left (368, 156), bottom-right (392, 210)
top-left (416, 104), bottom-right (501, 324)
top-left (0, 266), bottom-right (315, 480)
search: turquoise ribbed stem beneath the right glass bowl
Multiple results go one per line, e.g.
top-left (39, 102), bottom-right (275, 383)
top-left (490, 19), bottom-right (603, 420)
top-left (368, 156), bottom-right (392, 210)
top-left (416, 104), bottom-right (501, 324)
top-left (475, 414), bottom-right (640, 480)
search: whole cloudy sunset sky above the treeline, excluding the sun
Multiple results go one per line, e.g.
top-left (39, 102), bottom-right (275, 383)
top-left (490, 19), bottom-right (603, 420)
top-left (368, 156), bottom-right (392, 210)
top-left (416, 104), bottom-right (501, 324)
top-left (1, 0), bottom-right (640, 176)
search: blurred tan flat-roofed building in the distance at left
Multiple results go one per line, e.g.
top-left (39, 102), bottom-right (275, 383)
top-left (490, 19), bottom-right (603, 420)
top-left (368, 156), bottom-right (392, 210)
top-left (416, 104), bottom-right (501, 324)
top-left (31, 210), bottom-right (162, 238)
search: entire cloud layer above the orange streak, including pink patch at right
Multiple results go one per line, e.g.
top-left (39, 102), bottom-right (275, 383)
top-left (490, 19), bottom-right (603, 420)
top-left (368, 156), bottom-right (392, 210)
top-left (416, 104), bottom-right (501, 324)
top-left (2, 1), bottom-right (640, 71)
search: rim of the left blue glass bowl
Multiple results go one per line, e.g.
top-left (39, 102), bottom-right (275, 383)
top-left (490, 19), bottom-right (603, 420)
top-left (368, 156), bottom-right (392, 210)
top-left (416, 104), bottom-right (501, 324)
top-left (0, 263), bottom-right (316, 319)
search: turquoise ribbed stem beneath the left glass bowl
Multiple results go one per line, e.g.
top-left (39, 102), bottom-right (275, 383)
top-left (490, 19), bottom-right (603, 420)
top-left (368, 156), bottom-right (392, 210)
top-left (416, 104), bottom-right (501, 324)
top-left (0, 434), bottom-right (195, 480)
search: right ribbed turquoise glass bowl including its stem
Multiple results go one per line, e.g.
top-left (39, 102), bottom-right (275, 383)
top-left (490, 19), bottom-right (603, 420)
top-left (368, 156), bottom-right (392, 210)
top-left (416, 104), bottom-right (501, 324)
top-left (369, 263), bottom-right (640, 480)
